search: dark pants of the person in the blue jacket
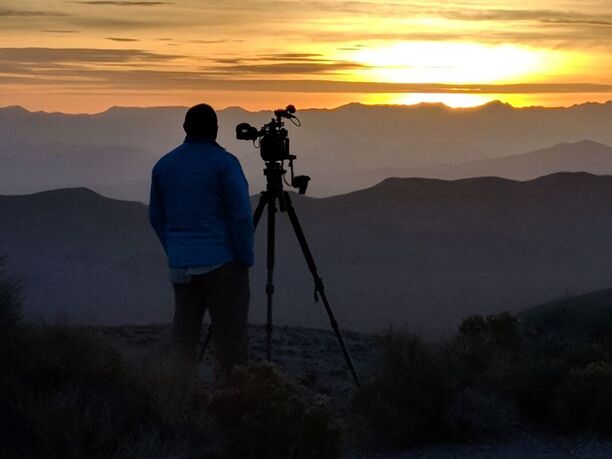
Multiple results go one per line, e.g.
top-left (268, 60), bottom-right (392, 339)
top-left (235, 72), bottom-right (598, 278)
top-left (172, 262), bottom-right (250, 372)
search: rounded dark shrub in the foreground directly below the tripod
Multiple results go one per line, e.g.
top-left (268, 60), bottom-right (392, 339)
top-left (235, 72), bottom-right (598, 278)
top-left (209, 365), bottom-right (341, 459)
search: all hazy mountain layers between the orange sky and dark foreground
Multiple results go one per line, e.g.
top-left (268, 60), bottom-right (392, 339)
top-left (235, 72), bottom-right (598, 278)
top-left (0, 102), bottom-right (612, 336)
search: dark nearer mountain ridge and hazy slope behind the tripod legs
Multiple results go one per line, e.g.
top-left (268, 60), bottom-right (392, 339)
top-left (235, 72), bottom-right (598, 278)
top-left (0, 173), bottom-right (612, 337)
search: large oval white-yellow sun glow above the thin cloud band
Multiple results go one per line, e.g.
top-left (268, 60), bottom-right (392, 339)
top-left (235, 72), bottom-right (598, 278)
top-left (348, 42), bottom-right (551, 84)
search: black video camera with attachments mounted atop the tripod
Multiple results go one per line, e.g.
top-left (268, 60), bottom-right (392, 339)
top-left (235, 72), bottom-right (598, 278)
top-left (236, 105), bottom-right (310, 194)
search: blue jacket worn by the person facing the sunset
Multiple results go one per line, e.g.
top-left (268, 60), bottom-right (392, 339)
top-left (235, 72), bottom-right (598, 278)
top-left (149, 136), bottom-right (254, 268)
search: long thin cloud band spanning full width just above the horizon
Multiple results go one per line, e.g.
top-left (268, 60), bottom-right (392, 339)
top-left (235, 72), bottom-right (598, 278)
top-left (0, 57), bottom-right (612, 94)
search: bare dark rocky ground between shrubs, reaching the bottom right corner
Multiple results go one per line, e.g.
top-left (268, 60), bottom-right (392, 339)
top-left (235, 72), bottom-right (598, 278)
top-left (97, 325), bottom-right (612, 459)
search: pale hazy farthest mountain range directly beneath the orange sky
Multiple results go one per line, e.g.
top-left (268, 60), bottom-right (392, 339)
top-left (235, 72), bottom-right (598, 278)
top-left (0, 101), bottom-right (612, 202)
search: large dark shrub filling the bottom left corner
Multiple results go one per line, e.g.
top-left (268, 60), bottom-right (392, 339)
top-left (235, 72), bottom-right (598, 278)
top-left (0, 326), bottom-right (215, 459)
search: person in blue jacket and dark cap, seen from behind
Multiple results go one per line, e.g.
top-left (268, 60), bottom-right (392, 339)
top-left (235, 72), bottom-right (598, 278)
top-left (149, 104), bottom-right (254, 374)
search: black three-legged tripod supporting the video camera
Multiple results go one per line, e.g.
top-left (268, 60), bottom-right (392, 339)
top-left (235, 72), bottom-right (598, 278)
top-left (200, 161), bottom-right (359, 386)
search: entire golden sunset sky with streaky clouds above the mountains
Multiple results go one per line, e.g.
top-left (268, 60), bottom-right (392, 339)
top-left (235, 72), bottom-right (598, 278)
top-left (0, 0), bottom-right (612, 113)
